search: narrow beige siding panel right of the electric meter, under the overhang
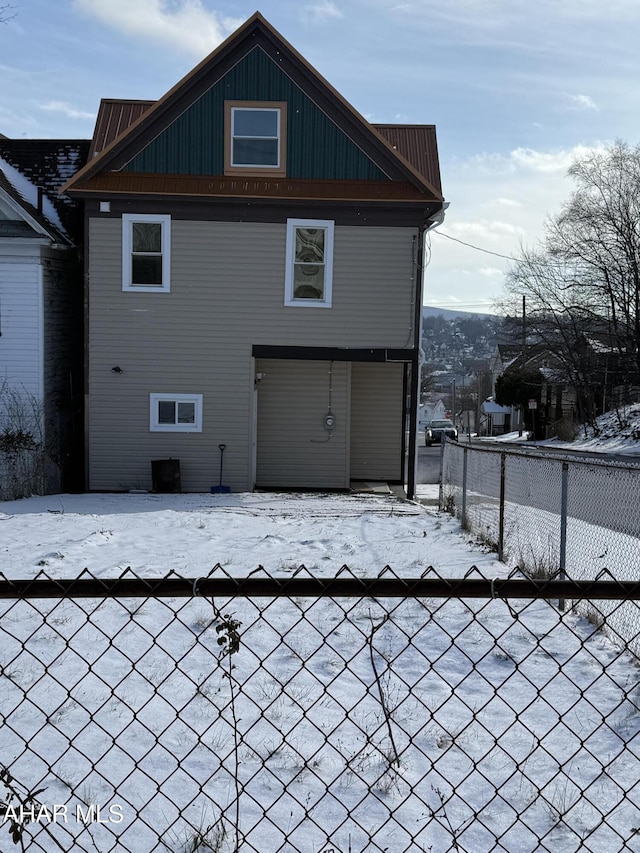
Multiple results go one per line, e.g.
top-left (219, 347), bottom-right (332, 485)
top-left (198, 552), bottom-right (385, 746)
top-left (350, 363), bottom-right (403, 481)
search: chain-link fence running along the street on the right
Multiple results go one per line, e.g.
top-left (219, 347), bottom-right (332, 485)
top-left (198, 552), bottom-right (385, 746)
top-left (441, 442), bottom-right (640, 656)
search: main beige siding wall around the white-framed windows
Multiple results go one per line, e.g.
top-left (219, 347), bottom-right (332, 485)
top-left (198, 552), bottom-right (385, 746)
top-left (88, 216), bottom-right (415, 491)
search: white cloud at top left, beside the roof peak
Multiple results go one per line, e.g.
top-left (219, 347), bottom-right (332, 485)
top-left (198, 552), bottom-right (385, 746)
top-left (73, 0), bottom-right (242, 58)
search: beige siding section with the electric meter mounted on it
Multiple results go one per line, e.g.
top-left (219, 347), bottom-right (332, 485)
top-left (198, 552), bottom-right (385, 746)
top-left (257, 359), bottom-right (350, 489)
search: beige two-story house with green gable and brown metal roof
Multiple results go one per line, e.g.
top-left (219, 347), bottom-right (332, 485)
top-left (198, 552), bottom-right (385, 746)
top-left (65, 13), bottom-right (443, 494)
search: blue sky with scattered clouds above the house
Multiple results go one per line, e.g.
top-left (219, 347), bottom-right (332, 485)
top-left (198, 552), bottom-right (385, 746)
top-left (0, 0), bottom-right (640, 312)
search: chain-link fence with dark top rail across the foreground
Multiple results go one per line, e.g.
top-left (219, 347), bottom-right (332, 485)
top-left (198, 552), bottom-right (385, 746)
top-left (0, 567), bottom-right (640, 853)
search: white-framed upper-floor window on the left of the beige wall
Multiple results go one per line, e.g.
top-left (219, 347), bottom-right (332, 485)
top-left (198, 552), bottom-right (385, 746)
top-left (122, 213), bottom-right (171, 293)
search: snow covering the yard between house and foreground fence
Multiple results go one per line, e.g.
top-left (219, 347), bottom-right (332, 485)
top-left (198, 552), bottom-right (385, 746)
top-left (0, 493), bottom-right (640, 853)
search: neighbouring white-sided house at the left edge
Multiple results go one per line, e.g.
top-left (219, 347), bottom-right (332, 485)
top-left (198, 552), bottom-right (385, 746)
top-left (0, 137), bottom-right (89, 491)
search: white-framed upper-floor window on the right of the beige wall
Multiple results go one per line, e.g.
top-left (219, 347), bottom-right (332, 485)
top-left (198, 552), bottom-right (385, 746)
top-left (284, 219), bottom-right (334, 308)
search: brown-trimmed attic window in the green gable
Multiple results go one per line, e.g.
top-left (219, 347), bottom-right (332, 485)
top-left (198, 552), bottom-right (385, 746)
top-left (224, 101), bottom-right (286, 176)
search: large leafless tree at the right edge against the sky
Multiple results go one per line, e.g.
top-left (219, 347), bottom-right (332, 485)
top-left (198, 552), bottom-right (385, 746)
top-left (507, 142), bottom-right (640, 420)
